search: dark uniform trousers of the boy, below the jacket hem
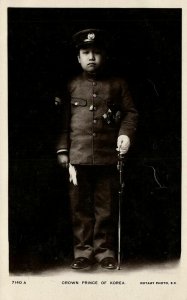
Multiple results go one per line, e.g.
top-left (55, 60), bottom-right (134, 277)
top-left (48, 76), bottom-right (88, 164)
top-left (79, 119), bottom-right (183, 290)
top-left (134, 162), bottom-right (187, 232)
top-left (70, 165), bottom-right (119, 261)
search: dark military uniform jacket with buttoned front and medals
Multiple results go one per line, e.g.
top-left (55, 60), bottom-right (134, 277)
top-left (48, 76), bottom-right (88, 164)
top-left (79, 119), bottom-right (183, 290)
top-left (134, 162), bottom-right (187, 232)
top-left (57, 72), bottom-right (138, 165)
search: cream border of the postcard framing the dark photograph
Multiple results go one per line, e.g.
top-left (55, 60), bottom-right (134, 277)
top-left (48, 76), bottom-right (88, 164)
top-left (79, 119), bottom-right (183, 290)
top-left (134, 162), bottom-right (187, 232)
top-left (0, 0), bottom-right (187, 300)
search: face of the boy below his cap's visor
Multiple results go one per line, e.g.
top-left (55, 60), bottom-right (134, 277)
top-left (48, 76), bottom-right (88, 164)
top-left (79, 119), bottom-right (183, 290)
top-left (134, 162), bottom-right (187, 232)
top-left (78, 47), bottom-right (106, 73)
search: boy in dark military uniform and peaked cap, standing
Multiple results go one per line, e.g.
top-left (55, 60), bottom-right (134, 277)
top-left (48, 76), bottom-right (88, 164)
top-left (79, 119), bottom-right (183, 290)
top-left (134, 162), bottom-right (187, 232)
top-left (57, 29), bottom-right (137, 269)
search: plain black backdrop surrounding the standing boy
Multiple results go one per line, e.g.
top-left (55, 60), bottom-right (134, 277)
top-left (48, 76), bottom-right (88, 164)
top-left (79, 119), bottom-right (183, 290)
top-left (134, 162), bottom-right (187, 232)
top-left (8, 8), bottom-right (182, 272)
